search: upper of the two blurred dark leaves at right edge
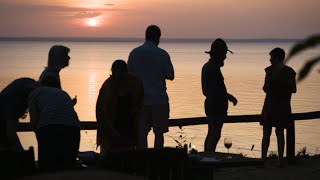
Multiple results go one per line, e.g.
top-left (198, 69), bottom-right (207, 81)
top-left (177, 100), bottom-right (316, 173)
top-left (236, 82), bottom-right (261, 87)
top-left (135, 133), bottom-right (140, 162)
top-left (284, 34), bottom-right (320, 62)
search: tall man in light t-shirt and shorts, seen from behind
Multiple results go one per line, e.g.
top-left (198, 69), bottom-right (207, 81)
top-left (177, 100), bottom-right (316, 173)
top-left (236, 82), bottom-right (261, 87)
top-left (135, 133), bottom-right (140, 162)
top-left (128, 25), bottom-right (174, 148)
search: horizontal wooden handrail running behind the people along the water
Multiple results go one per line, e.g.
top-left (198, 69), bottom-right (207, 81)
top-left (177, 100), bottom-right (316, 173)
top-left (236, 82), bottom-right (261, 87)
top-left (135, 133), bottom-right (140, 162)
top-left (18, 111), bottom-right (320, 132)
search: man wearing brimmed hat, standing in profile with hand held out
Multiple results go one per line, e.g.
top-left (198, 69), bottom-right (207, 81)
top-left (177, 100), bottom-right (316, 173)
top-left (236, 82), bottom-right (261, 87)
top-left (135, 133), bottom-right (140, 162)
top-left (201, 38), bottom-right (238, 152)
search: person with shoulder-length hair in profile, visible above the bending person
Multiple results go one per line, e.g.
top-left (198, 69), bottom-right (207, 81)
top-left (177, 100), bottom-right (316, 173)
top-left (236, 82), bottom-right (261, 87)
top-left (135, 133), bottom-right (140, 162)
top-left (39, 45), bottom-right (77, 104)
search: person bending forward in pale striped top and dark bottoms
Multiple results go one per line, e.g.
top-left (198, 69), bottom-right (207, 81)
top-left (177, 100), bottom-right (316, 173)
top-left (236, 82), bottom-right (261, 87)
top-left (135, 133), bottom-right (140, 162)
top-left (28, 76), bottom-right (80, 171)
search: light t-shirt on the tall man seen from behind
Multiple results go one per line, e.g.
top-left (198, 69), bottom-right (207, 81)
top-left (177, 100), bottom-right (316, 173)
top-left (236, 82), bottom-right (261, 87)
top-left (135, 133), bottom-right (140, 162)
top-left (128, 41), bottom-right (174, 105)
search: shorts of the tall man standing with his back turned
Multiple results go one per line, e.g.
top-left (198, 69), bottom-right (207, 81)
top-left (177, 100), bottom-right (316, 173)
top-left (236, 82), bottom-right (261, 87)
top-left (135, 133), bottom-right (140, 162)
top-left (140, 103), bottom-right (170, 134)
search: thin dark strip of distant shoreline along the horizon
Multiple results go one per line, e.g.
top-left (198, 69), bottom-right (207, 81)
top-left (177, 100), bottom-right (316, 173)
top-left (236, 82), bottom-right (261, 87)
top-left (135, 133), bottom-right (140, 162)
top-left (0, 37), bottom-right (302, 43)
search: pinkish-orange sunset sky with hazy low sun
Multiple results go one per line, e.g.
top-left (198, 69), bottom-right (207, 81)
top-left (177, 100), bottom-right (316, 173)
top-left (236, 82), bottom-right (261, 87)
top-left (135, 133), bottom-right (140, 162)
top-left (0, 0), bottom-right (320, 39)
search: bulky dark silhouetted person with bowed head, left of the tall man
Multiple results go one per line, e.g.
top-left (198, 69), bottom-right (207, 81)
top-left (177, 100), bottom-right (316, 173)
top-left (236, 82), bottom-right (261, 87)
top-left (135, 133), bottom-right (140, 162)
top-left (96, 60), bottom-right (143, 153)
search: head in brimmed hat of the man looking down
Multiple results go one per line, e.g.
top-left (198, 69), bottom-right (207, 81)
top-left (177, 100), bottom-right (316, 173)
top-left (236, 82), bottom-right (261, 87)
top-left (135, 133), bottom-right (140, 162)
top-left (206, 38), bottom-right (232, 66)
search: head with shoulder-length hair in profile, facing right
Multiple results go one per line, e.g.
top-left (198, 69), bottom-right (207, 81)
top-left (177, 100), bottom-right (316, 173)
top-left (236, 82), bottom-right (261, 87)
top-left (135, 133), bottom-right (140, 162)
top-left (48, 45), bottom-right (70, 70)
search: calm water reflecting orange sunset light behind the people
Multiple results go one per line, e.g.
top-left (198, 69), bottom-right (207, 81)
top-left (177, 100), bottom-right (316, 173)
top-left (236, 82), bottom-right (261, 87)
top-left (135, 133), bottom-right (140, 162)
top-left (0, 41), bottom-right (320, 157)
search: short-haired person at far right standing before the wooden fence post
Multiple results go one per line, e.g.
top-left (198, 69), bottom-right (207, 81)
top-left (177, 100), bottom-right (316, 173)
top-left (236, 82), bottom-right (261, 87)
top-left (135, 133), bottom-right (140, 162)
top-left (261, 48), bottom-right (297, 166)
